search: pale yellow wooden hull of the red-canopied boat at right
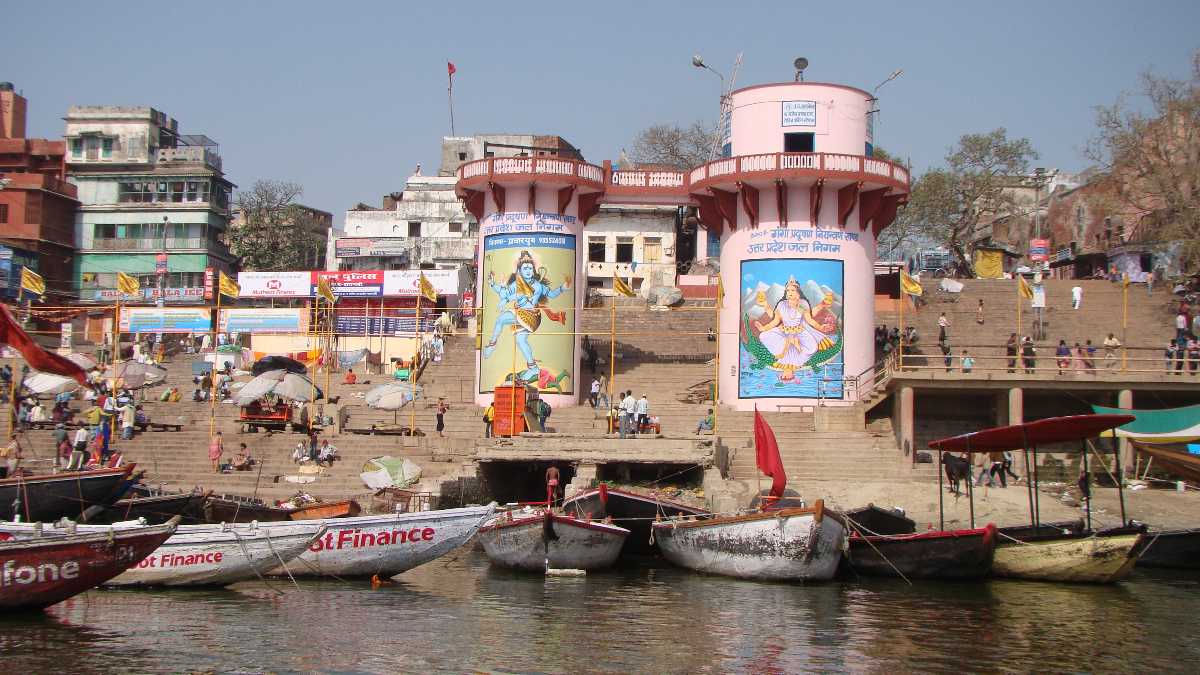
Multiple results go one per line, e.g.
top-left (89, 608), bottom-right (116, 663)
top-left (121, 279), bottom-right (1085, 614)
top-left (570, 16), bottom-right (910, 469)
top-left (991, 533), bottom-right (1144, 584)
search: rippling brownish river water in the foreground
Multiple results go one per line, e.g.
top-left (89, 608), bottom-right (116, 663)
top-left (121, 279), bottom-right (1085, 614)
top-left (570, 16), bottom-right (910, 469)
top-left (0, 550), bottom-right (1200, 673)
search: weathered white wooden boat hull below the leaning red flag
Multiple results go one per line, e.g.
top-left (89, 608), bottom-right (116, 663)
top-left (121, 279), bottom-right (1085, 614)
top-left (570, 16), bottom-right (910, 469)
top-left (653, 500), bottom-right (847, 581)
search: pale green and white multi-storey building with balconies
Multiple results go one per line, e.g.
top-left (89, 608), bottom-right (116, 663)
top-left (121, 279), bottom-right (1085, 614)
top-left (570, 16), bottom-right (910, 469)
top-left (64, 106), bottom-right (234, 301)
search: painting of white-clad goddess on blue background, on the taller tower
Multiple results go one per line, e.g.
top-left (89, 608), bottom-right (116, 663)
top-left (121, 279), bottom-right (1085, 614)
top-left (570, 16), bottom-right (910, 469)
top-left (738, 258), bottom-right (845, 399)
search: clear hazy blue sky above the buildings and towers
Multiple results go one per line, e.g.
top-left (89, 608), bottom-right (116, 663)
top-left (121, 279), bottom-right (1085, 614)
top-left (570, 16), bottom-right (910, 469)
top-left (0, 0), bottom-right (1200, 227)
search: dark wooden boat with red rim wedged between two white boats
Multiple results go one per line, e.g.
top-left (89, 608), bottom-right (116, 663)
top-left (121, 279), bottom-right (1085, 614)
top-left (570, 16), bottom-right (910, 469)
top-left (563, 486), bottom-right (709, 555)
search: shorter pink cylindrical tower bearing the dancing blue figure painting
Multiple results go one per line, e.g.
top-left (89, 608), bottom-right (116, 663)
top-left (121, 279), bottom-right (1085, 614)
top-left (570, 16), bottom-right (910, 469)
top-left (457, 157), bottom-right (604, 407)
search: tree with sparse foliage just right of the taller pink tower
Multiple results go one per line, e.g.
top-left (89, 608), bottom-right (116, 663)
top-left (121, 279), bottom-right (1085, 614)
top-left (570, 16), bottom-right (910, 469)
top-left (898, 129), bottom-right (1038, 275)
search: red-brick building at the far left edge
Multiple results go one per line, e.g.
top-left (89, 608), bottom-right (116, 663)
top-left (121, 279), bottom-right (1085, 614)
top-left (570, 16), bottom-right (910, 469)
top-left (0, 82), bottom-right (79, 303)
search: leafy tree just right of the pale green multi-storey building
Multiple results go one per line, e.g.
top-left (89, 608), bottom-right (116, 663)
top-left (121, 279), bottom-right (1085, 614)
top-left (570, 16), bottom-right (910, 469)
top-left (229, 180), bottom-right (324, 271)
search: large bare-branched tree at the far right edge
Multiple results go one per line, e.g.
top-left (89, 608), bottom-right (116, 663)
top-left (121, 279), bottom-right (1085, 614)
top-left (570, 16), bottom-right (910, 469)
top-left (1087, 50), bottom-right (1200, 269)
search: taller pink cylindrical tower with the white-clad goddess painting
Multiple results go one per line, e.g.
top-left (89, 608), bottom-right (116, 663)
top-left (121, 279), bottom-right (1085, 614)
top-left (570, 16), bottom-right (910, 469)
top-left (688, 82), bottom-right (908, 410)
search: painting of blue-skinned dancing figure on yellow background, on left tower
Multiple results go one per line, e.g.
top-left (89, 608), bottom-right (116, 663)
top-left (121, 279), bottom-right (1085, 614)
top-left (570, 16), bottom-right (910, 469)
top-left (479, 232), bottom-right (575, 394)
